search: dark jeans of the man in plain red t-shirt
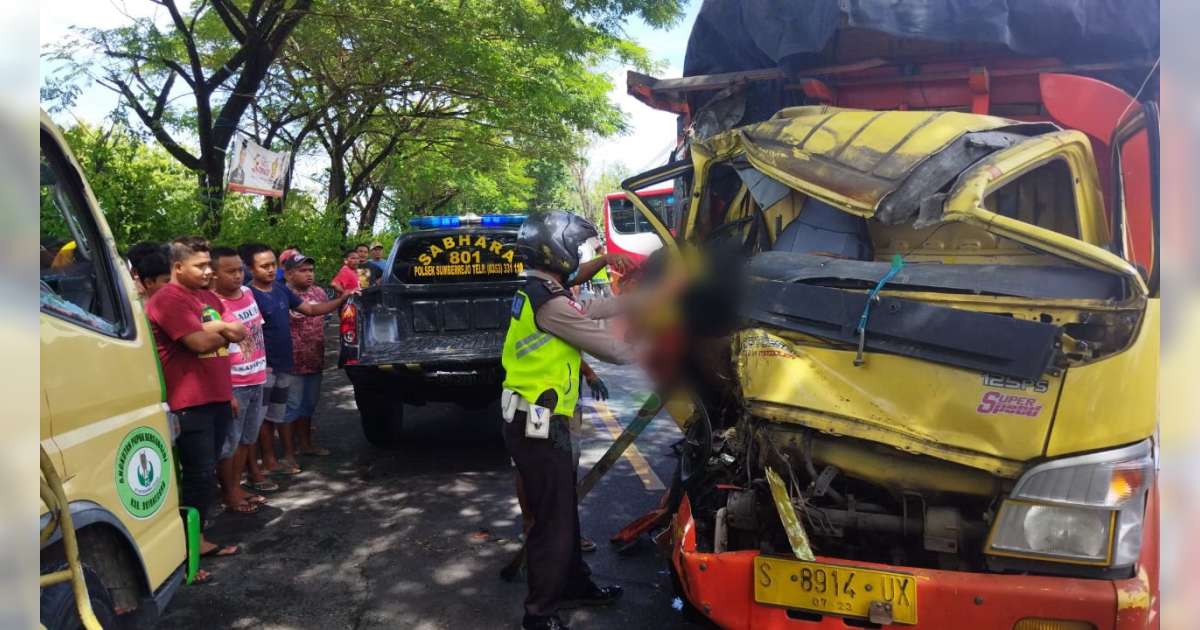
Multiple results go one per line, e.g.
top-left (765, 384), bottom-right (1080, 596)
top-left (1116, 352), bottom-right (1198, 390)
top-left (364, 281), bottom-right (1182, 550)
top-left (175, 402), bottom-right (233, 529)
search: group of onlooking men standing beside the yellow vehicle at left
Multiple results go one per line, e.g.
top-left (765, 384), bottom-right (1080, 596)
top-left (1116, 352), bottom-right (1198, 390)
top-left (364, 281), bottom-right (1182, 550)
top-left (126, 236), bottom-right (372, 582)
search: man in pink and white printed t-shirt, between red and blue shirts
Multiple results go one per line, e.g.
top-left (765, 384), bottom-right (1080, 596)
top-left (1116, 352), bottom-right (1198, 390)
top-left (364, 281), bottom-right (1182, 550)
top-left (212, 247), bottom-right (280, 514)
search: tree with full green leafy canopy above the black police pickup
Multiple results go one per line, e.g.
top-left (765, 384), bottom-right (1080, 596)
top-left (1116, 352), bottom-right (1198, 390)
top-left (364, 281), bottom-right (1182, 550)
top-left (281, 0), bottom-right (673, 233)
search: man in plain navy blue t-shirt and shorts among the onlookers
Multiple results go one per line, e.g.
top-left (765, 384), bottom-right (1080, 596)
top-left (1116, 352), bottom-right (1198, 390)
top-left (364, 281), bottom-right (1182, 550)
top-left (244, 245), bottom-right (359, 474)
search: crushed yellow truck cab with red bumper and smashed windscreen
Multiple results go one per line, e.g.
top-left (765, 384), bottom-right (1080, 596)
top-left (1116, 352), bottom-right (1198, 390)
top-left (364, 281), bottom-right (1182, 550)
top-left (626, 107), bottom-right (1159, 629)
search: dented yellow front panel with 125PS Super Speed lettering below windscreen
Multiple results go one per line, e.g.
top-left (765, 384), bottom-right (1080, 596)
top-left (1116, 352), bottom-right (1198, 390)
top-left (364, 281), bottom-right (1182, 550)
top-left (732, 329), bottom-right (1062, 476)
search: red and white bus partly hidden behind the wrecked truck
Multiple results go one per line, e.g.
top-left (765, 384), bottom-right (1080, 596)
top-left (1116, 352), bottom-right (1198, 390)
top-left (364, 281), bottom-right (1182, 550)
top-left (604, 187), bottom-right (676, 293)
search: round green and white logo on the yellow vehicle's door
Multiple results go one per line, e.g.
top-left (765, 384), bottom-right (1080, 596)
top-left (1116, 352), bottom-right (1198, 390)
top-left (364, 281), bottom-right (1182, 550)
top-left (116, 426), bottom-right (170, 518)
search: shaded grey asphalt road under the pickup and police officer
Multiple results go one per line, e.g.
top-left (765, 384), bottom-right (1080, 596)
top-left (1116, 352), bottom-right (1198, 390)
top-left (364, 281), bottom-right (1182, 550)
top-left (160, 336), bottom-right (688, 630)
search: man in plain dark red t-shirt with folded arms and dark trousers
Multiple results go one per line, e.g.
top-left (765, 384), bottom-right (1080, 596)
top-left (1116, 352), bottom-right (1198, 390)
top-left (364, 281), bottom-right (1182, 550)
top-left (146, 236), bottom-right (246, 575)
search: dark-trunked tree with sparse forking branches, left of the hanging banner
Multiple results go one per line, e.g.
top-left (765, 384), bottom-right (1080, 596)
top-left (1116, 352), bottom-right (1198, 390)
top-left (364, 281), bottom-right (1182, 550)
top-left (54, 0), bottom-right (313, 236)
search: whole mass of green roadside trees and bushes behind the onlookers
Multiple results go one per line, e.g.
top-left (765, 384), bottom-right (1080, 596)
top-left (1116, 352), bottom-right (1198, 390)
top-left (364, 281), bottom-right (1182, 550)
top-left (42, 0), bottom-right (684, 254)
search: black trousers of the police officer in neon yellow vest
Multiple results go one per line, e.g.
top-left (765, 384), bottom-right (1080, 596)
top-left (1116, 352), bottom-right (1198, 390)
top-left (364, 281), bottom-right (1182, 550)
top-left (504, 412), bottom-right (592, 617)
